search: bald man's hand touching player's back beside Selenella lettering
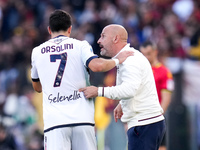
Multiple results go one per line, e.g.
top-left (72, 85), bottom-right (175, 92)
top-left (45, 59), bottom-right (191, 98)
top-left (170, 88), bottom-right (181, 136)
top-left (79, 86), bottom-right (98, 98)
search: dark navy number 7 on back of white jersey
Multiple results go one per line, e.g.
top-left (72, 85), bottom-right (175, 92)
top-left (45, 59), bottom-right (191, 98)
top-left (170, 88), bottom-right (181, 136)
top-left (50, 53), bottom-right (67, 87)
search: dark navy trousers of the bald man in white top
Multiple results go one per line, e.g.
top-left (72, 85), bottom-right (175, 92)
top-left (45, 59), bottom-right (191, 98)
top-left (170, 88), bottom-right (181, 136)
top-left (127, 120), bottom-right (166, 150)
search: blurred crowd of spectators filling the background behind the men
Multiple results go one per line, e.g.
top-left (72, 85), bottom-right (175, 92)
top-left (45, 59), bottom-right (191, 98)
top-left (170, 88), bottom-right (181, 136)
top-left (0, 0), bottom-right (200, 150)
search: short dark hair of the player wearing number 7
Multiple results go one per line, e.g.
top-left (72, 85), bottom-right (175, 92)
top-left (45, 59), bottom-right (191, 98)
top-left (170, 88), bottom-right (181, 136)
top-left (49, 10), bottom-right (72, 32)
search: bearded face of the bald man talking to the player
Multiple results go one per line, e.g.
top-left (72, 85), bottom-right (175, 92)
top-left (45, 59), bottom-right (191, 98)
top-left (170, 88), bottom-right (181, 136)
top-left (97, 27), bottom-right (114, 57)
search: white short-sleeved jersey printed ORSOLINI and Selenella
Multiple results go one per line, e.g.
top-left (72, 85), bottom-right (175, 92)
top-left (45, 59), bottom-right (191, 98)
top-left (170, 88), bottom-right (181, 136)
top-left (31, 36), bottom-right (97, 130)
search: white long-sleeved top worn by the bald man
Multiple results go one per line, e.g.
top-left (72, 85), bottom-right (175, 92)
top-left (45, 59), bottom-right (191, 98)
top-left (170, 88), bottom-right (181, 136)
top-left (101, 44), bottom-right (164, 128)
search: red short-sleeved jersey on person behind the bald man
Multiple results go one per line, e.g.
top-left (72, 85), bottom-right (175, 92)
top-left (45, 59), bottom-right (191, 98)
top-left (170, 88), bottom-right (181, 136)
top-left (152, 63), bottom-right (174, 103)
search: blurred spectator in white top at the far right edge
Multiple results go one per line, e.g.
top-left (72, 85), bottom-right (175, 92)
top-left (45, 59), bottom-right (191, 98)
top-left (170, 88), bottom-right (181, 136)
top-left (183, 28), bottom-right (200, 150)
